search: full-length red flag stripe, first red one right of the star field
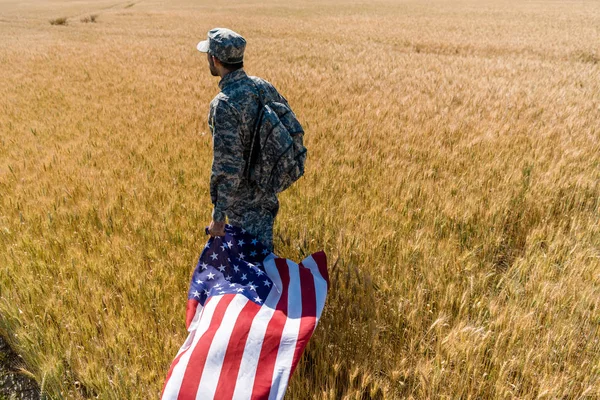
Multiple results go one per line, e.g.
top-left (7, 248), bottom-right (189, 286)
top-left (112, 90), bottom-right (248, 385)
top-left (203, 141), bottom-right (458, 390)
top-left (251, 258), bottom-right (290, 400)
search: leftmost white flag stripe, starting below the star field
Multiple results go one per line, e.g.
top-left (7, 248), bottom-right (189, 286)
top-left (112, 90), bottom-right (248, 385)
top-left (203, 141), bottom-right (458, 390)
top-left (162, 296), bottom-right (222, 400)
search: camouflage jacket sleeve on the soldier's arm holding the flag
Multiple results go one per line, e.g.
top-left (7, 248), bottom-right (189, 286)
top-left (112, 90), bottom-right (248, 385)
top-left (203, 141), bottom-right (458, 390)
top-left (208, 100), bottom-right (244, 222)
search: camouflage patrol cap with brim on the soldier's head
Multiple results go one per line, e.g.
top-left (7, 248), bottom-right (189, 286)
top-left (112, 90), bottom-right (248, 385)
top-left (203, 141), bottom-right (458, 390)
top-left (196, 28), bottom-right (246, 64)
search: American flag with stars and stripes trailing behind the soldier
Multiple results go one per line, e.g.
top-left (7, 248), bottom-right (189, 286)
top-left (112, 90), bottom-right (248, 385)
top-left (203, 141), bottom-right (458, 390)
top-left (162, 225), bottom-right (329, 400)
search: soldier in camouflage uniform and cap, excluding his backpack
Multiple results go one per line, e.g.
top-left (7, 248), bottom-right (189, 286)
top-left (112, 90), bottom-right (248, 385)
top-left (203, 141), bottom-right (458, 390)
top-left (197, 28), bottom-right (294, 251)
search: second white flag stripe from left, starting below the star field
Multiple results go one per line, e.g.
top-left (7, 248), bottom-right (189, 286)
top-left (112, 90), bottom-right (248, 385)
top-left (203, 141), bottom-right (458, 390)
top-left (196, 294), bottom-right (249, 400)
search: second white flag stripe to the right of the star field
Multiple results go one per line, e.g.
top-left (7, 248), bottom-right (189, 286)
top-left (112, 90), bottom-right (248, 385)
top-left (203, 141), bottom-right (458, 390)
top-left (269, 260), bottom-right (302, 400)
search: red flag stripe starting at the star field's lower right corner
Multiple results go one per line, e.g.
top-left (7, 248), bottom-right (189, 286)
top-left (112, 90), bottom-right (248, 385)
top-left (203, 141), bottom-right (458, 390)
top-left (215, 301), bottom-right (261, 400)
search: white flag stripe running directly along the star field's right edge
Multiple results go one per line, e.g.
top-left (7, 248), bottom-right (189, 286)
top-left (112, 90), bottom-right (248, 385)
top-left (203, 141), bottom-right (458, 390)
top-left (232, 256), bottom-right (282, 400)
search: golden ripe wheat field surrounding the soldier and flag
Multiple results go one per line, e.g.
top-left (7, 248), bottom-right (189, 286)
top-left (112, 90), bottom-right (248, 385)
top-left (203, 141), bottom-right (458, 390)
top-left (0, 0), bottom-right (600, 400)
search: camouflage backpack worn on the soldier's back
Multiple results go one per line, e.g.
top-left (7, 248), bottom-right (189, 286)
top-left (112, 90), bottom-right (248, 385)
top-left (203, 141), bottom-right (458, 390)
top-left (244, 80), bottom-right (307, 193)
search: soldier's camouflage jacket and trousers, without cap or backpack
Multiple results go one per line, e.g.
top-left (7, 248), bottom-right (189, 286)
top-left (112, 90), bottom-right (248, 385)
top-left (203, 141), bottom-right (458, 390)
top-left (208, 69), bottom-right (287, 250)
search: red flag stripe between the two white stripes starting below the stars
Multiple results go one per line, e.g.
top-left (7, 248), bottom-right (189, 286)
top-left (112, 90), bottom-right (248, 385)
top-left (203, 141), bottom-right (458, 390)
top-left (177, 294), bottom-right (235, 400)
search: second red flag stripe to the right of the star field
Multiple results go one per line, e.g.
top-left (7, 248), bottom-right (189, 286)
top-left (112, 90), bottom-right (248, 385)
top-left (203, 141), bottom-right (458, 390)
top-left (290, 263), bottom-right (317, 377)
